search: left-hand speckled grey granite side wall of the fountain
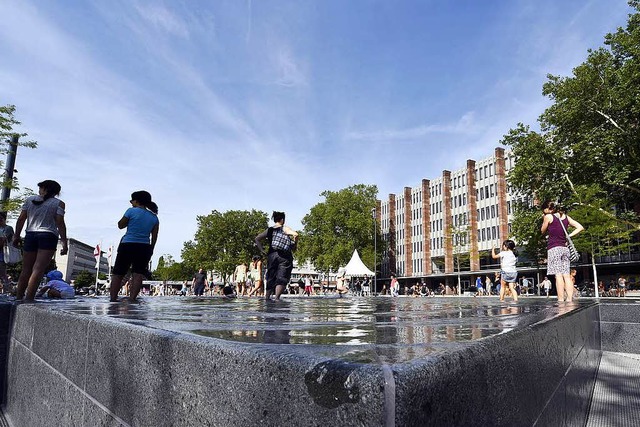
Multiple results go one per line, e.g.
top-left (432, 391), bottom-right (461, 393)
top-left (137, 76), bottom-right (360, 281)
top-left (4, 304), bottom-right (384, 427)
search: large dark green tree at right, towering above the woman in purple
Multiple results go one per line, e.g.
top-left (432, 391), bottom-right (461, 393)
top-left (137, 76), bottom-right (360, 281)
top-left (502, 1), bottom-right (640, 254)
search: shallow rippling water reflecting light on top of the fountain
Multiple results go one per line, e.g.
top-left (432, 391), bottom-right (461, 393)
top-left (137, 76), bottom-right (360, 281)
top-left (3, 296), bottom-right (594, 363)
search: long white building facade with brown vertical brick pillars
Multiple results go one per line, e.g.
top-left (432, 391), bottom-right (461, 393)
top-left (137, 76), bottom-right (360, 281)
top-left (376, 148), bottom-right (516, 278)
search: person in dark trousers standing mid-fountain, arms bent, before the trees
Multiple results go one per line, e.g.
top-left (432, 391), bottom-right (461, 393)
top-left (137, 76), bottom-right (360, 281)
top-left (255, 211), bottom-right (298, 300)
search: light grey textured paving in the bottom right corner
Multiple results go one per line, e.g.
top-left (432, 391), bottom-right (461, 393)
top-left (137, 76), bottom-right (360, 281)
top-left (587, 351), bottom-right (640, 427)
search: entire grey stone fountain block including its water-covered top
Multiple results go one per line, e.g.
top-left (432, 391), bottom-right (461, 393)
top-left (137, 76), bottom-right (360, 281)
top-left (0, 297), bottom-right (600, 427)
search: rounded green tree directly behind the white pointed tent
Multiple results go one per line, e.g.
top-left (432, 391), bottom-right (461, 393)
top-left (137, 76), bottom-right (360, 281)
top-left (296, 184), bottom-right (384, 271)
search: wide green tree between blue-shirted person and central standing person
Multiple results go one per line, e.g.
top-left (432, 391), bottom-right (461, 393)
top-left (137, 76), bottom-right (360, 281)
top-left (181, 209), bottom-right (269, 281)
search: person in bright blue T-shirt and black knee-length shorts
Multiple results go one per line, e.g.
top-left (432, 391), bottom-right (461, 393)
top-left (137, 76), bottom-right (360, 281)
top-left (109, 191), bottom-right (160, 302)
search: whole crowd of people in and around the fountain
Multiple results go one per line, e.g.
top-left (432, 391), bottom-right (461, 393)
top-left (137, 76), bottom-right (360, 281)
top-left (0, 184), bottom-right (627, 302)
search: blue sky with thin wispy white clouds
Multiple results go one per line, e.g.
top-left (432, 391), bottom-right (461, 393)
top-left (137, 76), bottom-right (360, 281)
top-left (0, 0), bottom-right (631, 266)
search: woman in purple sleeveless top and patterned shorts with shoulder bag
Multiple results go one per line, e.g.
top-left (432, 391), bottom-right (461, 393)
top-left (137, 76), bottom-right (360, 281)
top-left (540, 200), bottom-right (584, 301)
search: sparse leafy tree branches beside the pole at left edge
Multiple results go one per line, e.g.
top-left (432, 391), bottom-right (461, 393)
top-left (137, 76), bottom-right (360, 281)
top-left (0, 105), bottom-right (38, 212)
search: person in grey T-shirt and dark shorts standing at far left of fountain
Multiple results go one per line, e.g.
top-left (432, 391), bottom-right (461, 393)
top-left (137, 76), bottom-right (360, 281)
top-left (13, 179), bottom-right (69, 301)
